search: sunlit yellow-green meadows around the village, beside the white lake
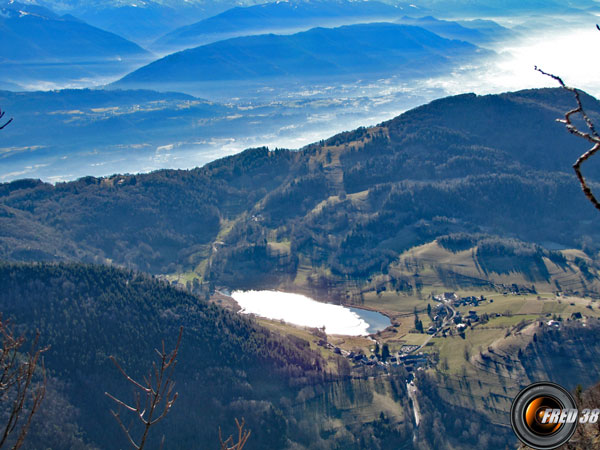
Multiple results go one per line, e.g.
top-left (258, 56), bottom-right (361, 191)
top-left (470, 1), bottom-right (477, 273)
top-left (207, 268), bottom-right (600, 381)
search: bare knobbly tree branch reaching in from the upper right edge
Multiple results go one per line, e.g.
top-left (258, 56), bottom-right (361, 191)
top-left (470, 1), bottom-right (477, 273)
top-left (535, 65), bottom-right (600, 210)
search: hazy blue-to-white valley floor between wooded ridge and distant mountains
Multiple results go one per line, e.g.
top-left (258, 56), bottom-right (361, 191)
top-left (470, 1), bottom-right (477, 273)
top-left (0, 3), bottom-right (600, 182)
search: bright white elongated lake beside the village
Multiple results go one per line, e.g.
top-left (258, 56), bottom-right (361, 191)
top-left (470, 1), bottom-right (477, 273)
top-left (231, 291), bottom-right (391, 336)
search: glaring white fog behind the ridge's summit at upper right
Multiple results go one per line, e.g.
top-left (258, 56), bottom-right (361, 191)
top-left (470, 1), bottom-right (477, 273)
top-left (425, 14), bottom-right (600, 96)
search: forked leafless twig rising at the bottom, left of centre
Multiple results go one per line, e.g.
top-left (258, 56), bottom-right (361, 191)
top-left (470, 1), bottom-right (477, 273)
top-left (105, 327), bottom-right (183, 450)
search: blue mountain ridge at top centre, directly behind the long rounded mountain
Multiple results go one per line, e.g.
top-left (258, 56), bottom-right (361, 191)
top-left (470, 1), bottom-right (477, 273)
top-left (153, 0), bottom-right (419, 50)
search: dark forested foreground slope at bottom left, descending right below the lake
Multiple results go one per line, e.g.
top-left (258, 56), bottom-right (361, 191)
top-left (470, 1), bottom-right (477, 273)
top-left (0, 263), bottom-right (512, 450)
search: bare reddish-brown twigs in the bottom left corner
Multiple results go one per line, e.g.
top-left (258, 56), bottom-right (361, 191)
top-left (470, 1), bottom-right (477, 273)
top-left (0, 314), bottom-right (49, 449)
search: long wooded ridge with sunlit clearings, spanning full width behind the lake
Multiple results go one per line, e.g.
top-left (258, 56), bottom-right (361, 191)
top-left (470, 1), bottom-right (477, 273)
top-left (0, 89), bottom-right (600, 287)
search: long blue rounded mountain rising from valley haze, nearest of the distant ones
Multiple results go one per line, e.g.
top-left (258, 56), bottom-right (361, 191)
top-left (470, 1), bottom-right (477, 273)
top-left (113, 23), bottom-right (485, 89)
